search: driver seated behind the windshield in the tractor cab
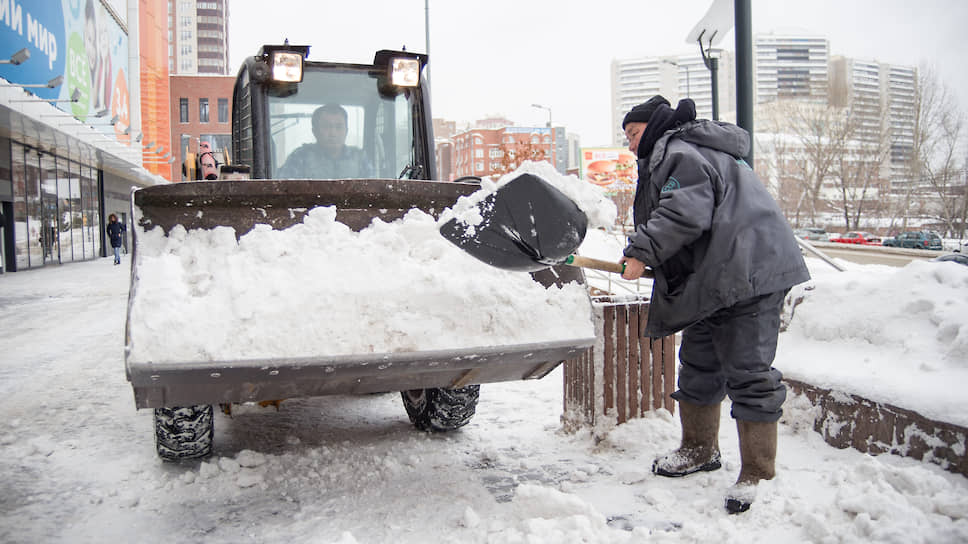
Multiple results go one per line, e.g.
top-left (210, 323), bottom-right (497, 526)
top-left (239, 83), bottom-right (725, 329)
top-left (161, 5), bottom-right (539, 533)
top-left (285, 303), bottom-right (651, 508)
top-left (275, 104), bottom-right (372, 179)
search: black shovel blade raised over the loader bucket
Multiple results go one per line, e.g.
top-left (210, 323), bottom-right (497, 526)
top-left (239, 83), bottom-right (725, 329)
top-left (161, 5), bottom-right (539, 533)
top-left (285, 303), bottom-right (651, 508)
top-left (440, 174), bottom-right (588, 272)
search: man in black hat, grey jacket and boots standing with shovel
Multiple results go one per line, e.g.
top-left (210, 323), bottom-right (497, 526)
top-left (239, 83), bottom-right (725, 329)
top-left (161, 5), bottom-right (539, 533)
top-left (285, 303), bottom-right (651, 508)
top-left (621, 95), bottom-right (810, 513)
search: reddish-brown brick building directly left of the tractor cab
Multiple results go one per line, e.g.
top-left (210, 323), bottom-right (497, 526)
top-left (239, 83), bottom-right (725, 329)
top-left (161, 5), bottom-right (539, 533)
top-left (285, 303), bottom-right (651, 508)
top-left (168, 75), bottom-right (235, 180)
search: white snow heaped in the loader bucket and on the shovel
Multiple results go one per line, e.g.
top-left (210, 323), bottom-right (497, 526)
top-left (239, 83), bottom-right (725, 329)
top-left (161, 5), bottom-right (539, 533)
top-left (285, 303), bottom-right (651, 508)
top-left (129, 165), bottom-right (614, 362)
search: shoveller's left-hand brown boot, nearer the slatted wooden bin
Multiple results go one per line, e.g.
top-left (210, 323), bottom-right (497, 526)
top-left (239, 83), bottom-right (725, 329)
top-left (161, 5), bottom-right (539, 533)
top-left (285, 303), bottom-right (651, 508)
top-left (652, 401), bottom-right (723, 478)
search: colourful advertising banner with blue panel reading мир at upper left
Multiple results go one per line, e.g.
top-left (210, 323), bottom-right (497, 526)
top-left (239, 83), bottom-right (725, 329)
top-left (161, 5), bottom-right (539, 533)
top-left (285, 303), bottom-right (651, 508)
top-left (0, 0), bottom-right (130, 132)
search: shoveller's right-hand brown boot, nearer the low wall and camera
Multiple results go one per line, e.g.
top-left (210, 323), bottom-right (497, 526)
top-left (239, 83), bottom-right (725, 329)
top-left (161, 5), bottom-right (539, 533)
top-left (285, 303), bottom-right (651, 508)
top-left (726, 419), bottom-right (777, 514)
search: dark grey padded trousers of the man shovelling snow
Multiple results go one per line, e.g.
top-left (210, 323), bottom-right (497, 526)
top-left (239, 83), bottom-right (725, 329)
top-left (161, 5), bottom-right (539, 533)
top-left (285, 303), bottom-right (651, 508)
top-left (672, 291), bottom-right (787, 422)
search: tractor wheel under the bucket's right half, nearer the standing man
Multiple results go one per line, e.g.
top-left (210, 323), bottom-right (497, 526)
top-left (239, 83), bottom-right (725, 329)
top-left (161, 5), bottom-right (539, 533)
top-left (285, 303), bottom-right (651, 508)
top-left (400, 385), bottom-right (481, 432)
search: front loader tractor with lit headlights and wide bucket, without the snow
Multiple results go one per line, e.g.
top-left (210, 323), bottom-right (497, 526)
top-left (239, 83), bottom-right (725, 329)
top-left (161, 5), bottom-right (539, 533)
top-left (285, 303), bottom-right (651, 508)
top-left (126, 43), bottom-right (594, 459)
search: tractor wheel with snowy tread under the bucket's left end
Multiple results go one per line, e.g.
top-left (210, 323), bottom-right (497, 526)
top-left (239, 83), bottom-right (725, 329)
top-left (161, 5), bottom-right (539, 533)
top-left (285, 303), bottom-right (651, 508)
top-left (155, 404), bottom-right (214, 461)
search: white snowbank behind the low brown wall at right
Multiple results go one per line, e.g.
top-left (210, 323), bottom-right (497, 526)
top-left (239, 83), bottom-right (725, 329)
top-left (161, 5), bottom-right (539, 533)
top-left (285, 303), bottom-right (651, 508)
top-left (774, 261), bottom-right (968, 425)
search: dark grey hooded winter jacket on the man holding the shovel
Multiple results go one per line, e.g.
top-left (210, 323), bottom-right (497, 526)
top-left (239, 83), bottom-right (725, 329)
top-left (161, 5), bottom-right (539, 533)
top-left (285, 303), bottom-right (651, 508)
top-left (625, 120), bottom-right (810, 337)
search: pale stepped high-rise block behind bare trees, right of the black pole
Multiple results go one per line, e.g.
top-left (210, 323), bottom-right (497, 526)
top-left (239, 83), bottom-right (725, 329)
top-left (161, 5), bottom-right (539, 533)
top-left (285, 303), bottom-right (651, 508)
top-left (754, 34), bottom-right (918, 215)
